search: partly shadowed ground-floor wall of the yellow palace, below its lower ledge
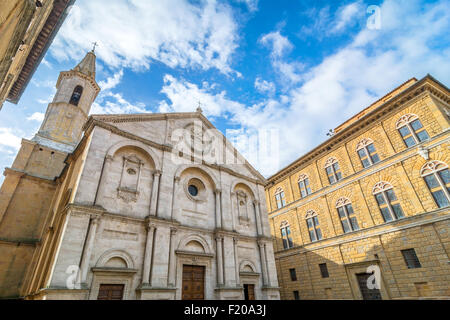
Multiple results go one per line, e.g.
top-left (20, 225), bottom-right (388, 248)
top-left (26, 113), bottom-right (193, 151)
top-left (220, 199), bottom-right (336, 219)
top-left (274, 219), bottom-right (450, 300)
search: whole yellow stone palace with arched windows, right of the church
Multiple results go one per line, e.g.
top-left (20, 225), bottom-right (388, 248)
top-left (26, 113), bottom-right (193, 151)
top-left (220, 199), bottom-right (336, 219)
top-left (266, 76), bottom-right (450, 299)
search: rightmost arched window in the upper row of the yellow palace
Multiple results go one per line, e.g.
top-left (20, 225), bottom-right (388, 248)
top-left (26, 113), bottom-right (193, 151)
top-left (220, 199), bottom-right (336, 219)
top-left (396, 113), bottom-right (430, 148)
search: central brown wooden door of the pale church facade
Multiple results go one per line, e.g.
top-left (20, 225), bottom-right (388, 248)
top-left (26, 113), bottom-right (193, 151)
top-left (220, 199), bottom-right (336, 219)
top-left (181, 265), bottom-right (205, 300)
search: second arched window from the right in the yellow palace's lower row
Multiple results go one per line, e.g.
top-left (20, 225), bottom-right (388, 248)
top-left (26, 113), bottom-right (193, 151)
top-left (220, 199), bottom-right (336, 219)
top-left (373, 181), bottom-right (405, 222)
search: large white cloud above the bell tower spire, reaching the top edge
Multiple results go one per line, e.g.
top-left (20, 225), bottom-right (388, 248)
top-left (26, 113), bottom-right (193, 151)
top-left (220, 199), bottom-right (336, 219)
top-left (51, 0), bottom-right (238, 74)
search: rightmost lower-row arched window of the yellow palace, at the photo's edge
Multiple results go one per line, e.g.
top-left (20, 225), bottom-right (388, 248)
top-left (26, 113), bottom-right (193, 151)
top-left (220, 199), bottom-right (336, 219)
top-left (420, 161), bottom-right (450, 208)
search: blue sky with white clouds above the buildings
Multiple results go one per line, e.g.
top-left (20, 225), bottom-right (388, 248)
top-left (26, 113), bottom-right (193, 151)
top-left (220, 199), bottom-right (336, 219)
top-left (0, 0), bottom-right (450, 179)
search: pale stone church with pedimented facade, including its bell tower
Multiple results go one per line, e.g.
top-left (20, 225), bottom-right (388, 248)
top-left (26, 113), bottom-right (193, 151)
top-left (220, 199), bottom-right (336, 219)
top-left (0, 51), bottom-right (279, 300)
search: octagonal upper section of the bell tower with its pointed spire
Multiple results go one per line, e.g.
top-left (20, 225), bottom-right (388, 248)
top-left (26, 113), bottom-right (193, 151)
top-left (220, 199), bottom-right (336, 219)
top-left (32, 49), bottom-right (100, 153)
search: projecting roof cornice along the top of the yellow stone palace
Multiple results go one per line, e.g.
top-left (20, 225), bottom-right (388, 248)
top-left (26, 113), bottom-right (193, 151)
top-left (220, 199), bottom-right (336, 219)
top-left (266, 75), bottom-right (450, 187)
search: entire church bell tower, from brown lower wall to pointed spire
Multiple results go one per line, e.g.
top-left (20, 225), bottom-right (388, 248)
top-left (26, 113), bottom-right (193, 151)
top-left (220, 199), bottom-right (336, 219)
top-left (0, 50), bottom-right (100, 298)
